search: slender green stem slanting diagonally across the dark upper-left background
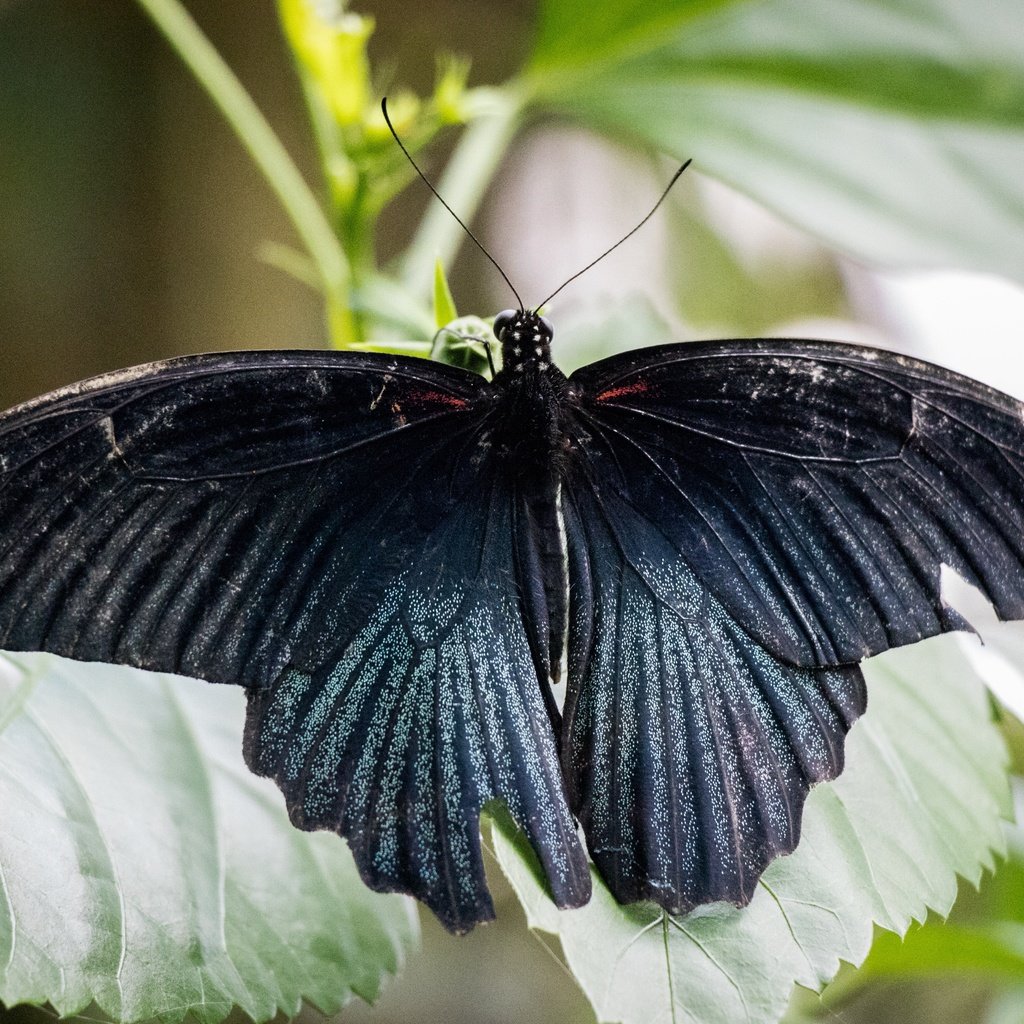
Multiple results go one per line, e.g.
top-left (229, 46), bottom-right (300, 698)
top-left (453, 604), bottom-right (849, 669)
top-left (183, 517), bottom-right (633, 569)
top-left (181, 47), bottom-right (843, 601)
top-left (132, 0), bottom-right (358, 345)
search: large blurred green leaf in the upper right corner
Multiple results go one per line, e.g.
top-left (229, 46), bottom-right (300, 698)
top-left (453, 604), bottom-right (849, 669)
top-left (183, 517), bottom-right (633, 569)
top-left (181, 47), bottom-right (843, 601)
top-left (529, 0), bottom-right (1024, 279)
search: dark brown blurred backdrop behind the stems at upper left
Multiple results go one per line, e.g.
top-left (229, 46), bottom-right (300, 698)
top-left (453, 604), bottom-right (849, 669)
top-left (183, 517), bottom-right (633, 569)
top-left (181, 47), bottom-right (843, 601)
top-left (0, 0), bottom-right (531, 407)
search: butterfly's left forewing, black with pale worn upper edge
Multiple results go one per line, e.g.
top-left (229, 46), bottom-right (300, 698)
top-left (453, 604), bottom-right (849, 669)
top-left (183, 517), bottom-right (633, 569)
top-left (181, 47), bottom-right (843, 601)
top-left (0, 352), bottom-right (479, 686)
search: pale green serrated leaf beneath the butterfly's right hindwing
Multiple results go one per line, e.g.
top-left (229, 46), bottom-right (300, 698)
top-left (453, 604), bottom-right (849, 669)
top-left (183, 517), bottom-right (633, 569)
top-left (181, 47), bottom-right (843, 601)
top-left (495, 637), bottom-right (1009, 1024)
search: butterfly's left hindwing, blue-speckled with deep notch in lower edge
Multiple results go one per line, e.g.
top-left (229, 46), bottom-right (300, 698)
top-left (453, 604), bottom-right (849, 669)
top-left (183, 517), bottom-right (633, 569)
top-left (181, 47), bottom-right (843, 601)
top-left (246, 466), bottom-right (590, 931)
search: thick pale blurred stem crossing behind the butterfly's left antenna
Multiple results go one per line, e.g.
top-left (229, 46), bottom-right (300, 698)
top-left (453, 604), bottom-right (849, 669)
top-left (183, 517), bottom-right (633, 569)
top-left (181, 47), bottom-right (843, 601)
top-left (399, 88), bottom-right (523, 300)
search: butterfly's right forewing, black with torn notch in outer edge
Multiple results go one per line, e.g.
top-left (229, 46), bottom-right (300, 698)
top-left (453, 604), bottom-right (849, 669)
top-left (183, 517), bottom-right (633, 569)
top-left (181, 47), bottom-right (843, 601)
top-left (571, 340), bottom-right (1024, 667)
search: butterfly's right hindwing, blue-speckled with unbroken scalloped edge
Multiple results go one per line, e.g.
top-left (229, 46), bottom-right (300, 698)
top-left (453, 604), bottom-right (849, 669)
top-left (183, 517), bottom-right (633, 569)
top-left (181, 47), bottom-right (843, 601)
top-left (562, 450), bottom-right (865, 912)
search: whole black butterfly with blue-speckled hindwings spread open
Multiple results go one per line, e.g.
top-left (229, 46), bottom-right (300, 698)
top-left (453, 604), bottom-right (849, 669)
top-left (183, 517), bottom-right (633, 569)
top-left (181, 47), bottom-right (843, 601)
top-left (0, 309), bottom-right (1024, 932)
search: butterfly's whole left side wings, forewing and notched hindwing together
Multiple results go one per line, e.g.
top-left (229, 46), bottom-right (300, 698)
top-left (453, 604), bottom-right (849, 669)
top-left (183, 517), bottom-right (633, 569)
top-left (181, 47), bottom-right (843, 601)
top-left (0, 352), bottom-right (589, 930)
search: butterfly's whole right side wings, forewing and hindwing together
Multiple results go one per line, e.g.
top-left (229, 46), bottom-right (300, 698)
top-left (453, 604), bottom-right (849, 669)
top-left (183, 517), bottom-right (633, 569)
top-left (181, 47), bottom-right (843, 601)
top-left (562, 341), bottom-right (1024, 911)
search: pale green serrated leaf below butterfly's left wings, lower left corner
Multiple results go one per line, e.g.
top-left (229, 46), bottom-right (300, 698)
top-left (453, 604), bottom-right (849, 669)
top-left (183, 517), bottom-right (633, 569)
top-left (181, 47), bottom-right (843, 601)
top-left (0, 655), bottom-right (417, 1024)
